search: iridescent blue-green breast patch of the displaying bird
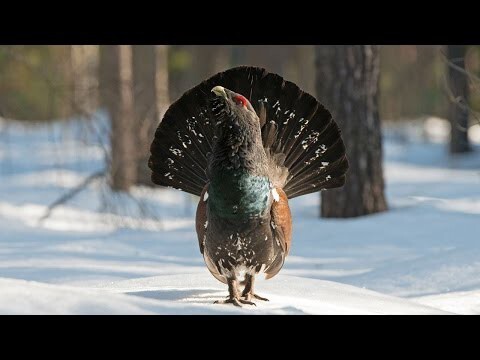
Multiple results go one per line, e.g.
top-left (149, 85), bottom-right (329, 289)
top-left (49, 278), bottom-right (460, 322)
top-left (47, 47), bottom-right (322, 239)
top-left (208, 169), bottom-right (270, 219)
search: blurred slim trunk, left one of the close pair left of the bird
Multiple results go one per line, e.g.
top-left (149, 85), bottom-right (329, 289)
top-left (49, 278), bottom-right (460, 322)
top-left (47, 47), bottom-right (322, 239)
top-left (99, 45), bottom-right (137, 191)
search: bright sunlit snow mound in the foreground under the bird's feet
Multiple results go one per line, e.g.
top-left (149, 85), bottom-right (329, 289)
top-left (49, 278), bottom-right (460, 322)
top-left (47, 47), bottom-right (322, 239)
top-left (0, 274), bottom-right (448, 315)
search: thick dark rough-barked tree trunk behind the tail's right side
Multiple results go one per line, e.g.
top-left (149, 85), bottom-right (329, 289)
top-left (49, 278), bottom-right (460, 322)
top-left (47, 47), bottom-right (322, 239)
top-left (316, 45), bottom-right (387, 218)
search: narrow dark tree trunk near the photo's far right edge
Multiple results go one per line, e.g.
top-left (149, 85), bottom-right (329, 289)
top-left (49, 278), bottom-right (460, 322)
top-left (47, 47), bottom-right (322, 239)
top-left (447, 45), bottom-right (471, 154)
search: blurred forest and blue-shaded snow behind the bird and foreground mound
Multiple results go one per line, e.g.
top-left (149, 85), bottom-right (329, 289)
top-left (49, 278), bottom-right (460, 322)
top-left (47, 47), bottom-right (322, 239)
top-left (0, 45), bottom-right (480, 312)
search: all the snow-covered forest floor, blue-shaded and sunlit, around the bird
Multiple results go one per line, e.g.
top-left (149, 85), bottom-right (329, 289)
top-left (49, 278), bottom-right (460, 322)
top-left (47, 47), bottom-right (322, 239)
top-left (0, 116), bottom-right (480, 314)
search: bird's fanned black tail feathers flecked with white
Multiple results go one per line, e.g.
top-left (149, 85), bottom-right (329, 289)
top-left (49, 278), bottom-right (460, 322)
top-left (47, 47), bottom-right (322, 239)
top-left (149, 66), bottom-right (348, 198)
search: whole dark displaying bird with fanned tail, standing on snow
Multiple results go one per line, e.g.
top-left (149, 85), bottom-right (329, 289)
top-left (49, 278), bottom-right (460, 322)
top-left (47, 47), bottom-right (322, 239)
top-left (149, 66), bottom-right (348, 306)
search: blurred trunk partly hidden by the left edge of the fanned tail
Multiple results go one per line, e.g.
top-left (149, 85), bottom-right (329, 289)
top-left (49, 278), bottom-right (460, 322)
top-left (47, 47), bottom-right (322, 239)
top-left (133, 45), bottom-right (169, 186)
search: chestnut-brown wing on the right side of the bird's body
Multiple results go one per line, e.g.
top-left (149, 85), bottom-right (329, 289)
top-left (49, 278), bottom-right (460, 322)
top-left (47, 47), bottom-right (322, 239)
top-left (265, 187), bottom-right (292, 279)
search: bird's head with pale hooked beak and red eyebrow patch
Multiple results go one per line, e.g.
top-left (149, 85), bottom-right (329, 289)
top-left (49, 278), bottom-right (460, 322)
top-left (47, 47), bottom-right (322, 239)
top-left (210, 86), bottom-right (260, 130)
